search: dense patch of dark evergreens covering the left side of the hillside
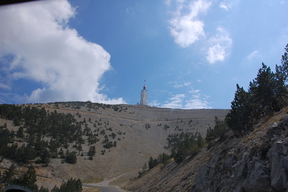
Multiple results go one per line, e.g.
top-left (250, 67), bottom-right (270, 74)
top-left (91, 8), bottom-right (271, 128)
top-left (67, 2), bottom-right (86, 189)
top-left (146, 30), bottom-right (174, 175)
top-left (0, 105), bottom-right (83, 164)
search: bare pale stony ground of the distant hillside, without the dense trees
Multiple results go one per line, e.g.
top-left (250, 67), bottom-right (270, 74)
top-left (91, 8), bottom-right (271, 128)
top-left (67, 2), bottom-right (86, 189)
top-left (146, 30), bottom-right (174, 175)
top-left (0, 102), bottom-right (228, 188)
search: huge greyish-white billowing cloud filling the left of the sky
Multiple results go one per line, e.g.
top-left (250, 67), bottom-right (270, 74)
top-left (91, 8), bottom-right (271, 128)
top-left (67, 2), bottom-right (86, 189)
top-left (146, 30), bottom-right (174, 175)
top-left (0, 0), bottom-right (124, 103)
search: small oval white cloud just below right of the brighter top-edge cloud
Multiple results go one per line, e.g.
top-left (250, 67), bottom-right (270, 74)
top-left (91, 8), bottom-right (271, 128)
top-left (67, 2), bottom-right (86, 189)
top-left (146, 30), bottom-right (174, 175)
top-left (206, 27), bottom-right (232, 64)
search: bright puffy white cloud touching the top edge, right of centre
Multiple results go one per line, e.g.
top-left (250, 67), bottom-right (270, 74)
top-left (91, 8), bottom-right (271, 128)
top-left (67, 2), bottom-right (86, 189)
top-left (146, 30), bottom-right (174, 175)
top-left (169, 0), bottom-right (211, 47)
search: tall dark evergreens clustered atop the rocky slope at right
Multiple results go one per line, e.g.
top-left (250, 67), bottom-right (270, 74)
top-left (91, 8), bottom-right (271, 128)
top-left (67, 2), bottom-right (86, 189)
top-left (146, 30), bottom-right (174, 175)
top-left (226, 44), bottom-right (288, 136)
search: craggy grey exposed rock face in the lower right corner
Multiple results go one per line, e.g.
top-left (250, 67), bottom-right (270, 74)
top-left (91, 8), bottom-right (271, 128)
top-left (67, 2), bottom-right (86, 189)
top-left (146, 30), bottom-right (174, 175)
top-left (191, 115), bottom-right (288, 192)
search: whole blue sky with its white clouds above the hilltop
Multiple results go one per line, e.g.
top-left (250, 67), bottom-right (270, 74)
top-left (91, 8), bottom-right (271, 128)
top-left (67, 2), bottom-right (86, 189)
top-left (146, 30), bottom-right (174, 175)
top-left (0, 0), bottom-right (288, 109)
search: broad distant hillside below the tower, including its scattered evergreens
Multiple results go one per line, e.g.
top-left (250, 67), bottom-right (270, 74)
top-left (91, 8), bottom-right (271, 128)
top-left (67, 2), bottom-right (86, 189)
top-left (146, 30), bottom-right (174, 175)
top-left (0, 102), bottom-right (229, 188)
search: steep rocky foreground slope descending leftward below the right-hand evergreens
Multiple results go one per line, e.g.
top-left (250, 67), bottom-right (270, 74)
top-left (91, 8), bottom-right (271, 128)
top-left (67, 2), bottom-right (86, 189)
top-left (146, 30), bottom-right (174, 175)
top-left (123, 108), bottom-right (288, 192)
